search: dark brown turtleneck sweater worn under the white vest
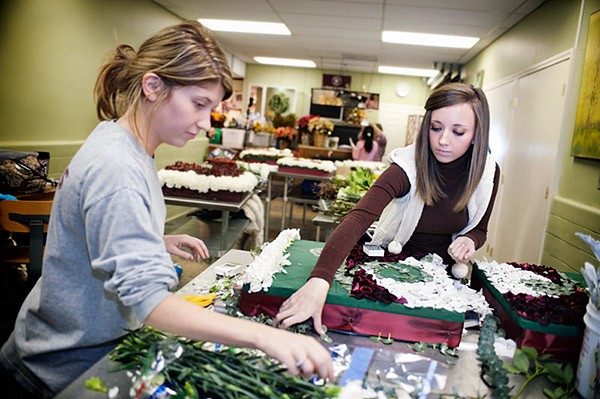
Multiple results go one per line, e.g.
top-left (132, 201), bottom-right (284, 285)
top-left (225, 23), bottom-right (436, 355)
top-left (310, 151), bottom-right (500, 284)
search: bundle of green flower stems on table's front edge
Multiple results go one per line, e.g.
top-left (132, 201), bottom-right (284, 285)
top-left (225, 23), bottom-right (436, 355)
top-left (110, 327), bottom-right (339, 399)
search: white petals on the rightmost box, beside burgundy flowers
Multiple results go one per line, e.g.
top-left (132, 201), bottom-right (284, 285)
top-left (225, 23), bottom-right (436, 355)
top-left (477, 261), bottom-right (554, 296)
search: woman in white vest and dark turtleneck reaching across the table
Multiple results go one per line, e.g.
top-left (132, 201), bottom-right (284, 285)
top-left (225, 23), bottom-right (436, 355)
top-left (274, 83), bottom-right (500, 333)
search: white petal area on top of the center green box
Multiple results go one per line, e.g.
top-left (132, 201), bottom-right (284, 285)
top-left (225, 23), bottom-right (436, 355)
top-left (364, 254), bottom-right (492, 317)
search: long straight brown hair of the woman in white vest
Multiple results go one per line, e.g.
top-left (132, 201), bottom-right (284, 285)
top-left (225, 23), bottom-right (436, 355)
top-left (415, 83), bottom-right (490, 212)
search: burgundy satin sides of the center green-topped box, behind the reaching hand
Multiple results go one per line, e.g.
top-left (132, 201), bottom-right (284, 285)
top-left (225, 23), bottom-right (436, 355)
top-left (240, 291), bottom-right (463, 347)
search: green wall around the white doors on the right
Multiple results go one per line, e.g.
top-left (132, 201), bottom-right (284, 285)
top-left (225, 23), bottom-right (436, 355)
top-left (465, 0), bottom-right (600, 271)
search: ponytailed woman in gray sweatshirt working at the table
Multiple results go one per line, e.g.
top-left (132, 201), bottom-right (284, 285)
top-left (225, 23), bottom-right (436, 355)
top-left (0, 22), bottom-right (333, 398)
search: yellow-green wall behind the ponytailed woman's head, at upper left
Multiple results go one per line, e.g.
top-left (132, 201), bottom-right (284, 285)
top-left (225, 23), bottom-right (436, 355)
top-left (0, 0), bottom-right (199, 177)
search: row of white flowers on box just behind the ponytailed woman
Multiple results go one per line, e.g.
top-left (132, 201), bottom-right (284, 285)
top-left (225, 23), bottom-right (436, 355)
top-left (158, 169), bottom-right (258, 193)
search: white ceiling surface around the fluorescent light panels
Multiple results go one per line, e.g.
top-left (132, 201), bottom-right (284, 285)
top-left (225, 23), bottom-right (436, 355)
top-left (153, 0), bottom-right (545, 73)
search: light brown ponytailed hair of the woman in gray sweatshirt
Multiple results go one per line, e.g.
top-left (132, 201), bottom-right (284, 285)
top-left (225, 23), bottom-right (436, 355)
top-left (94, 21), bottom-right (233, 142)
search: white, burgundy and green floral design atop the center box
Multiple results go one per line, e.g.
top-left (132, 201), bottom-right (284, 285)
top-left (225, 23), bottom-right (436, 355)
top-left (335, 245), bottom-right (492, 317)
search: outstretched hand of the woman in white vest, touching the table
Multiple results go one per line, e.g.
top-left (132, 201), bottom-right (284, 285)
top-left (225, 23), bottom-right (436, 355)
top-left (273, 277), bottom-right (329, 334)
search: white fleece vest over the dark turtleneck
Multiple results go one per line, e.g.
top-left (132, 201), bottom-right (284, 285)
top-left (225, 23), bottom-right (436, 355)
top-left (373, 144), bottom-right (496, 254)
